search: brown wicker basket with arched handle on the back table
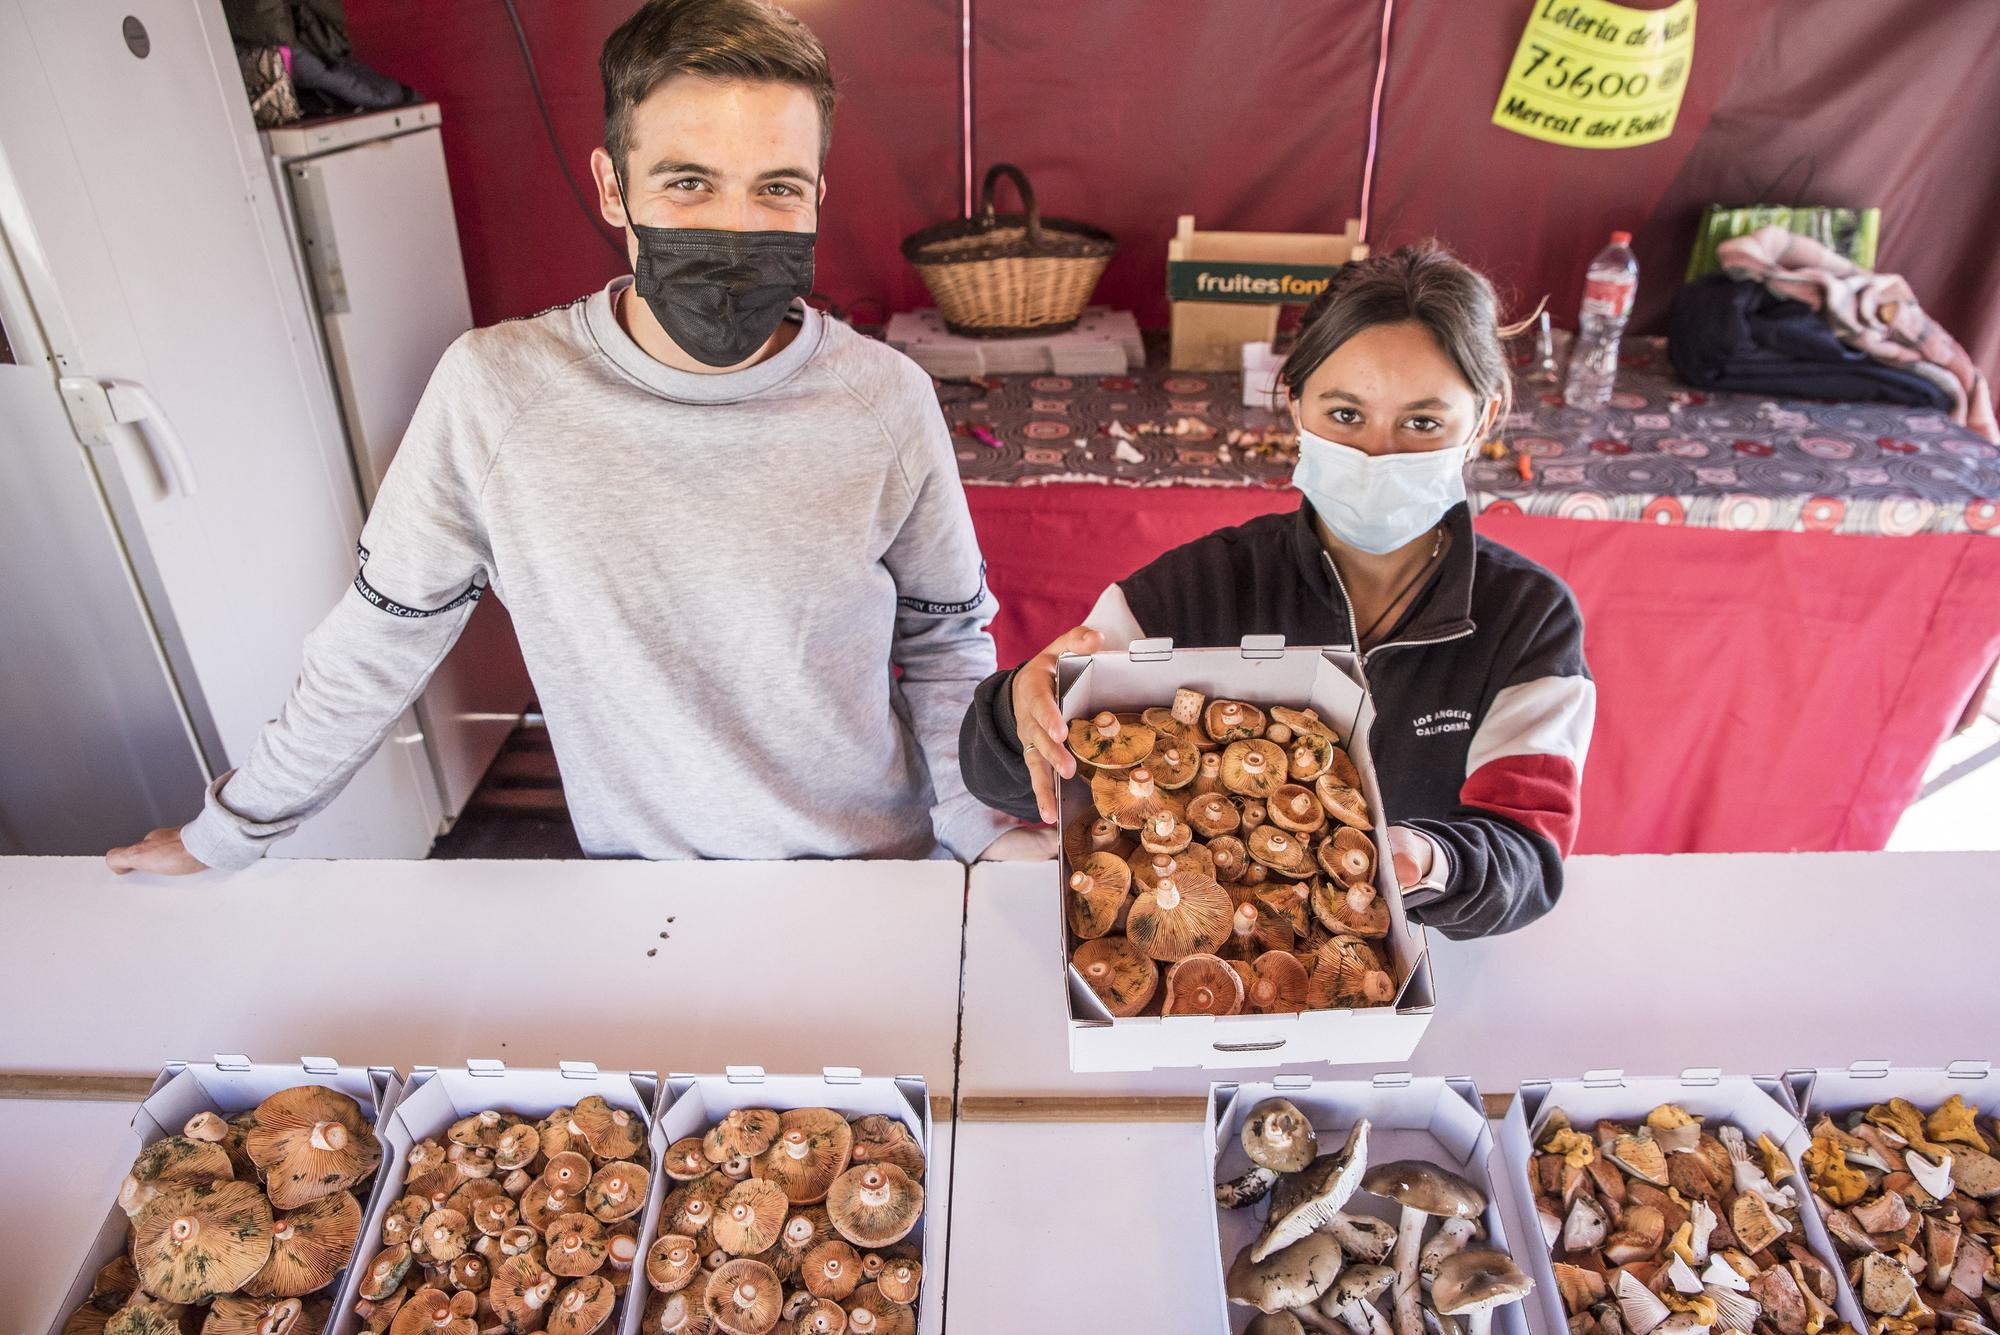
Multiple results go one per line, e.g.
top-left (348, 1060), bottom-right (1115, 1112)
top-left (902, 162), bottom-right (1118, 338)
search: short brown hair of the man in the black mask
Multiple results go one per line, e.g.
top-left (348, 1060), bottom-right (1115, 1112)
top-left (598, 0), bottom-right (834, 172)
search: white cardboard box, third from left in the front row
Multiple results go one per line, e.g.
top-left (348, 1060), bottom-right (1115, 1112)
top-left (652, 1065), bottom-right (944, 1335)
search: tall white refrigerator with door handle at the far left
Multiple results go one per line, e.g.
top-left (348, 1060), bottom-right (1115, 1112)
top-left (0, 0), bottom-right (524, 857)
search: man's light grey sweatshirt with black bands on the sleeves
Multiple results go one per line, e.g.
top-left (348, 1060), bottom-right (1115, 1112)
top-left (182, 278), bottom-right (1012, 867)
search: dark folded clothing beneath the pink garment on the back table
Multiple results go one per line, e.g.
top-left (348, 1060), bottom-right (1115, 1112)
top-left (1666, 274), bottom-right (1952, 412)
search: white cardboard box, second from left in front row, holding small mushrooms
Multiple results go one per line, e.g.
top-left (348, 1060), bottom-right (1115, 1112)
top-left (326, 1061), bottom-right (664, 1335)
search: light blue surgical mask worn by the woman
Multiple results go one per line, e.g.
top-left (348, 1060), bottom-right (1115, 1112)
top-left (1292, 428), bottom-right (1470, 556)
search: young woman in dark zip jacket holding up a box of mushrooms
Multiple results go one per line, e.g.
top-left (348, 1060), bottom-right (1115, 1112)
top-left (960, 244), bottom-right (1596, 937)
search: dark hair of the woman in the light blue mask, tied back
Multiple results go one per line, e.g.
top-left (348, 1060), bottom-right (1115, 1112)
top-left (1278, 242), bottom-right (1512, 414)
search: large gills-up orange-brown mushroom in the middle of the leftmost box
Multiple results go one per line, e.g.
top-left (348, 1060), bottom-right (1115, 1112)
top-left (132, 1181), bottom-right (272, 1303)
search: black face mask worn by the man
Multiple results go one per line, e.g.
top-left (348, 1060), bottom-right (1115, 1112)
top-left (618, 163), bottom-right (818, 366)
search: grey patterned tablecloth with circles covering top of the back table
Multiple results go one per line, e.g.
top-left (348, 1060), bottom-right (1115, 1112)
top-left (938, 338), bottom-right (2000, 536)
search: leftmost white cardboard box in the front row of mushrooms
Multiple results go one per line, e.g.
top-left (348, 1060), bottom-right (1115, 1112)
top-left (48, 1057), bottom-right (400, 1335)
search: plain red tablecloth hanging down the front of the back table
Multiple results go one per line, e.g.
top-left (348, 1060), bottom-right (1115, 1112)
top-left (966, 484), bottom-right (2000, 853)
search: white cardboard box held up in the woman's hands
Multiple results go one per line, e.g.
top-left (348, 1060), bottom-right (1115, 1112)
top-left (1050, 636), bottom-right (1436, 1071)
